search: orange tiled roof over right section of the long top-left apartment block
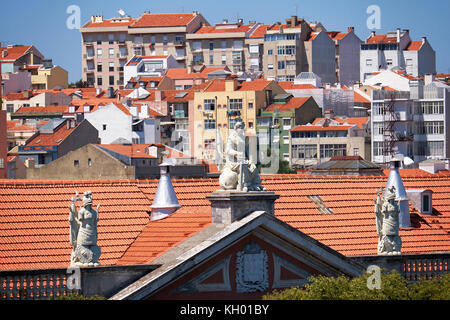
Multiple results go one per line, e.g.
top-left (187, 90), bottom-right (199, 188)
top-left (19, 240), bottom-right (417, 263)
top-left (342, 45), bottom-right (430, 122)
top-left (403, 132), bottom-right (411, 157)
top-left (130, 13), bottom-right (196, 28)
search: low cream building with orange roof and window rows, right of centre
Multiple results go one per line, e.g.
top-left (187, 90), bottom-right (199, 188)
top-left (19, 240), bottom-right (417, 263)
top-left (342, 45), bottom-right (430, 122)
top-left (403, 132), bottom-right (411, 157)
top-left (289, 110), bottom-right (370, 168)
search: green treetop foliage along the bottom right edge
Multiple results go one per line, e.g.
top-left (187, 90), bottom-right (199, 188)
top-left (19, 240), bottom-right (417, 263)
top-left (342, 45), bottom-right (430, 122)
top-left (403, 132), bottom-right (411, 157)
top-left (263, 271), bottom-right (450, 300)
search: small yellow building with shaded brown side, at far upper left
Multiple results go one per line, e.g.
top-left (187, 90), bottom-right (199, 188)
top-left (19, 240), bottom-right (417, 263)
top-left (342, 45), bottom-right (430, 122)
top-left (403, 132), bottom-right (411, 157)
top-left (28, 62), bottom-right (69, 90)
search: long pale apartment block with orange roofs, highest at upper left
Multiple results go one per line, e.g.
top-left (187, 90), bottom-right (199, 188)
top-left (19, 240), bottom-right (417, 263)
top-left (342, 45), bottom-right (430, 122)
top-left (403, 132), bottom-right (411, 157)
top-left (80, 12), bottom-right (209, 89)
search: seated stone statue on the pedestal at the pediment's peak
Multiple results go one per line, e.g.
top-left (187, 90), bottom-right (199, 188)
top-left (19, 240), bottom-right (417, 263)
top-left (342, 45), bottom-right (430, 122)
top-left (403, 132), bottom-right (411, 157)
top-left (219, 121), bottom-right (266, 192)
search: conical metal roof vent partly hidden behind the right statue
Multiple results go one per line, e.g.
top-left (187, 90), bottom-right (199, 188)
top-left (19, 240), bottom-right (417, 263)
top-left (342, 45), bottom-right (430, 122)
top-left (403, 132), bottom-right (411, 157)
top-left (384, 154), bottom-right (411, 228)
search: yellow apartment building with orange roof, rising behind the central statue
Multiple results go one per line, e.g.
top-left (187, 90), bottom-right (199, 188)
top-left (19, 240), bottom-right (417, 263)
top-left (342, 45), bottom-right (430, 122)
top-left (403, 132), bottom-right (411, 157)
top-left (191, 79), bottom-right (286, 161)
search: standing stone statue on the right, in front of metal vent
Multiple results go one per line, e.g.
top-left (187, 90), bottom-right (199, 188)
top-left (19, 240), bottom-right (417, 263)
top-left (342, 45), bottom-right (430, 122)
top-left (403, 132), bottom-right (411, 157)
top-left (375, 186), bottom-right (402, 255)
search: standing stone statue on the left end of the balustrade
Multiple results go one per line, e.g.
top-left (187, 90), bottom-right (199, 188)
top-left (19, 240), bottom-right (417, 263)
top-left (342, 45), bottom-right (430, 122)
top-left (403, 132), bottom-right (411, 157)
top-left (69, 191), bottom-right (101, 267)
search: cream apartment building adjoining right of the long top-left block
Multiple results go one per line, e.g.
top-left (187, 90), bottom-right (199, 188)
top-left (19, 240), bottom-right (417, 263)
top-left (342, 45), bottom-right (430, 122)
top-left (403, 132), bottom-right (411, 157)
top-left (186, 19), bottom-right (259, 74)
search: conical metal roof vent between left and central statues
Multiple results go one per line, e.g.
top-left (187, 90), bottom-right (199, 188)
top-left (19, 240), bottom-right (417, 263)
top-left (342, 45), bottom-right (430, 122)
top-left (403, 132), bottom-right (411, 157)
top-left (150, 161), bottom-right (181, 221)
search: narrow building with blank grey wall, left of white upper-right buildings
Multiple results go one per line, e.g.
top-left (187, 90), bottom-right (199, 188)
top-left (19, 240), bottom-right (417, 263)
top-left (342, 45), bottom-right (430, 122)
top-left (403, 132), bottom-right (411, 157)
top-left (327, 27), bottom-right (362, 86)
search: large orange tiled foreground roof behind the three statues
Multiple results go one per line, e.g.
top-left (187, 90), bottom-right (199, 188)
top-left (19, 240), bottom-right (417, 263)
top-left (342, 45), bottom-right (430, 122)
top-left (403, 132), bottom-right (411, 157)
top-left (0, 169), bottom-right (450, 270)
